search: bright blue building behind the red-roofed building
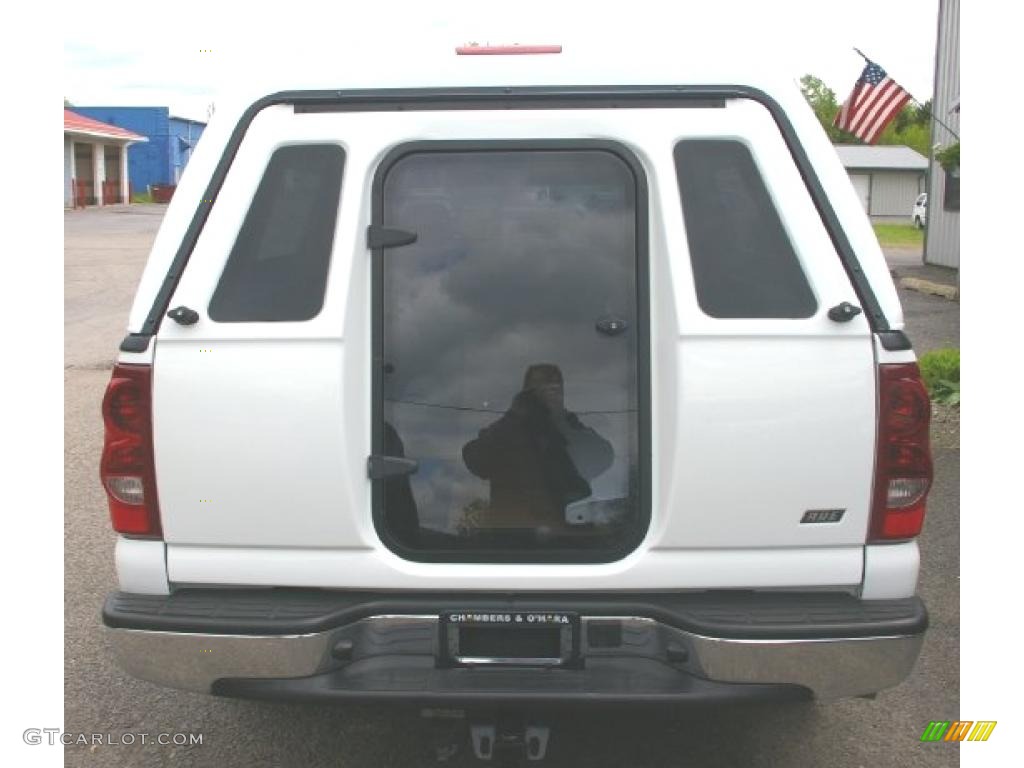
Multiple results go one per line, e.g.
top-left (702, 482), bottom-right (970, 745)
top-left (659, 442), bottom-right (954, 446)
top-left (75, 106), bottom-right (206, 194)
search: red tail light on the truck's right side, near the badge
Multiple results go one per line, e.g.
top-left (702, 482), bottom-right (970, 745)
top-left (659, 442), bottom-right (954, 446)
top-left (870, 362), bottom-right (932, 542)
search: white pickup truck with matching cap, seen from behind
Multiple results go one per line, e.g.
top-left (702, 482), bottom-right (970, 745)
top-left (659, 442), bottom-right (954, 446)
top-left (101, 55), bottom-right (932, 720)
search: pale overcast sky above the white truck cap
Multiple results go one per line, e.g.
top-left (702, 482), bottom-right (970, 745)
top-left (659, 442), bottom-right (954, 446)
top-left (63, 0), bottom-right (938, 120)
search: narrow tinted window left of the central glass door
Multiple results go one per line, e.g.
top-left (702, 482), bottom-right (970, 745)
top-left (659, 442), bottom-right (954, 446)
top-left (209, 144), bottom-right (345, 323)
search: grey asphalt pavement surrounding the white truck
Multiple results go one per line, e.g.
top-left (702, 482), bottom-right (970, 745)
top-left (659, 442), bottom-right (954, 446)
top-left (65, 206), bottom-right (959, 768)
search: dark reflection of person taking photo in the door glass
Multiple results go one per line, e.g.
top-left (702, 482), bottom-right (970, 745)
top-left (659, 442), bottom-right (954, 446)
top-left (462, 364), bottom-right (614, 529)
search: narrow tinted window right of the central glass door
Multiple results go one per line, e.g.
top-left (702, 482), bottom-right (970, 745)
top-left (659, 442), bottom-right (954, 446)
top-left (675, 139), bottom-right (817, 317)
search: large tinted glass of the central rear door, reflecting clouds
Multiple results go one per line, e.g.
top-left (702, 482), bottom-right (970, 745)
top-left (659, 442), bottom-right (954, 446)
top-left (375, 142), bottom-right (647, 561)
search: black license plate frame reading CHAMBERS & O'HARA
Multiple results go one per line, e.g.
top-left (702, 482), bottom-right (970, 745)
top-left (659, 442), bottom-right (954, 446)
top-left (438, 609), bottom-right (580, 668)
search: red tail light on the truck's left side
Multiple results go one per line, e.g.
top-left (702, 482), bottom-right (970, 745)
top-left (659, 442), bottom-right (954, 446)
top-left (99, 365), bottom-right (162, 538)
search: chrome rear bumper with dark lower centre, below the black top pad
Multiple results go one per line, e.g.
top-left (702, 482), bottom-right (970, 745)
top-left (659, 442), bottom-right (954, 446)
top-left (108, 614), bottom-right (924, 700)
